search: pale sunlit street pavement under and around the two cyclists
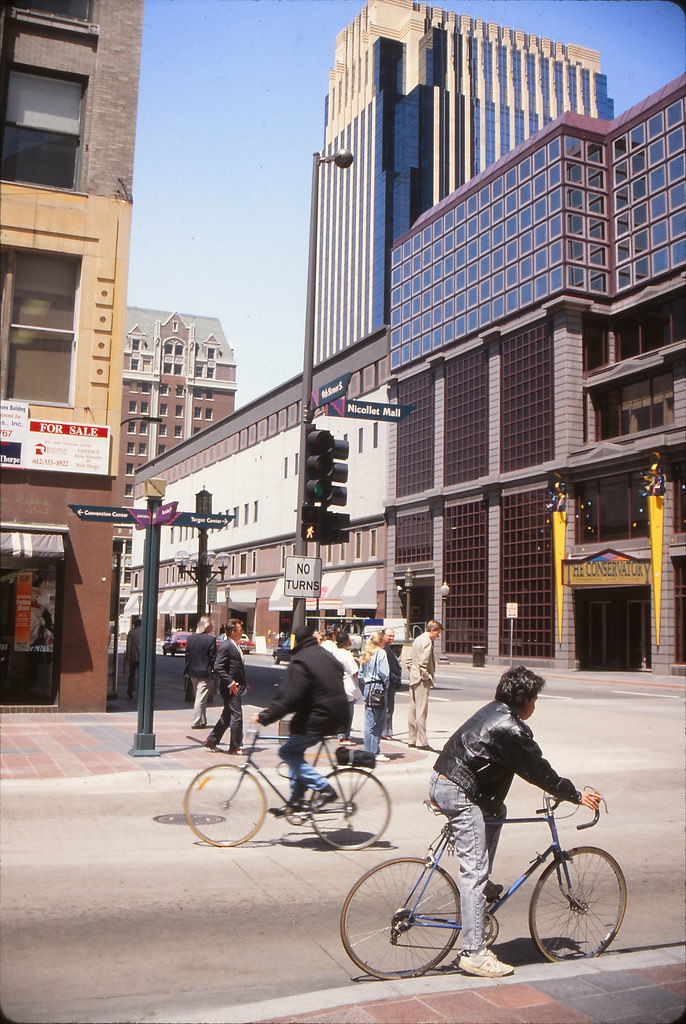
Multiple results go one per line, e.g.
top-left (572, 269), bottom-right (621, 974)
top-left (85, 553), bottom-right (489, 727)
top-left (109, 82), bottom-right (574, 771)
top-left (1, 656), bottom-right (684, 1022)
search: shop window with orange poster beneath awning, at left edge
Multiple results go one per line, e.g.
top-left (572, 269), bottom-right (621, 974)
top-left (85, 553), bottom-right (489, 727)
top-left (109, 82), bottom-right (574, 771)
top-left (0, 530), bottom-right (65, 706)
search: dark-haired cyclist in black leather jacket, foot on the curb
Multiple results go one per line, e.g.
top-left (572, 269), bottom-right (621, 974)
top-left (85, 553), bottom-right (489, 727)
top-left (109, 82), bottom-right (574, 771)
top-left (436, 666), bottom-right (601, 978)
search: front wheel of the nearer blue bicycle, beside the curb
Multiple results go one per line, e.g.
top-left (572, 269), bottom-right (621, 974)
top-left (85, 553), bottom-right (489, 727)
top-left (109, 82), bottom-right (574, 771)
top-left (528, 846), bottom-right (627, 961)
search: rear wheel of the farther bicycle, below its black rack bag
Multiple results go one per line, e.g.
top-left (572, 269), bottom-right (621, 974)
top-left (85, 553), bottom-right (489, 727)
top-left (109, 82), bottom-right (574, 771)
top-left (310, 768), bottom-right (391, 850)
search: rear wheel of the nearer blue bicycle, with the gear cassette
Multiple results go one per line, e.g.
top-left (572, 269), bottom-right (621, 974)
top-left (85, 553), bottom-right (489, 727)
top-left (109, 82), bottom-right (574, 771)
top-left (340, 857), bottom-right (461, 978)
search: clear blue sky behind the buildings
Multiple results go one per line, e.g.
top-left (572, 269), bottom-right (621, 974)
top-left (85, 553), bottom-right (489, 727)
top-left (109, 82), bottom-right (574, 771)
top-left (128, 0), bottom-right (686, 408)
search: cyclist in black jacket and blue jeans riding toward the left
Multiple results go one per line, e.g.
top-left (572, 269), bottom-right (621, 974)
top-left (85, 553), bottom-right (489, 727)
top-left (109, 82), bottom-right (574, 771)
top-left (254, 626), bottom-right (348, 814)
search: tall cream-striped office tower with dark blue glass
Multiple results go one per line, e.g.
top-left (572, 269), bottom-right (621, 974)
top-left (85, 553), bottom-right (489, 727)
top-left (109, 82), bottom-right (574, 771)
top-left (315, 0), bottom-right (613, 362)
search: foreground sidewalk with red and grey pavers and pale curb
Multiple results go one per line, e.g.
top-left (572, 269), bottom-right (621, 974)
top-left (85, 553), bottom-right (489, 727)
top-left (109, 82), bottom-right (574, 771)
top-left (223, 946), bottom-right (686, 1024)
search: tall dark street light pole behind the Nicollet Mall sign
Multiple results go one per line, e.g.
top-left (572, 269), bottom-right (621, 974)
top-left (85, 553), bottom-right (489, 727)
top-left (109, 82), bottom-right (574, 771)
top-left (292, 150), bottom-right (353, 631)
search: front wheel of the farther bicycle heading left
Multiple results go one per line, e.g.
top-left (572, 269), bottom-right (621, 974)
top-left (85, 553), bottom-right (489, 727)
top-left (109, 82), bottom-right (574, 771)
top-left (183, 765), bottom-right (266, 846)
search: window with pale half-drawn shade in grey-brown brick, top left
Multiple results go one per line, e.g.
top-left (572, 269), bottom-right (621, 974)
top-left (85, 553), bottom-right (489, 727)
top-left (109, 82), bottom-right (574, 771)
top-left (0, 71), bottom-right (82, 188)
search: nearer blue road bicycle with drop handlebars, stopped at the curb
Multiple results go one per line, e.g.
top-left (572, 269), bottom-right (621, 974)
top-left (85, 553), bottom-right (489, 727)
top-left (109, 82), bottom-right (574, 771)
top-left (340, 796), bottom-right (627, 978)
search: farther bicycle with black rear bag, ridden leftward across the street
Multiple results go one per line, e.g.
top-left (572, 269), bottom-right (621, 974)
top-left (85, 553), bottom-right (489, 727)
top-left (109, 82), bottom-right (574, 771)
top-left (183, 730), bottom-right (390, 850)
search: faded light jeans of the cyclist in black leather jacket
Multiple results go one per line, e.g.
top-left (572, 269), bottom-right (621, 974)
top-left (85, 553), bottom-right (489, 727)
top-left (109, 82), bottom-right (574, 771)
top-left (429, 771), bottom-right (507, 953)
